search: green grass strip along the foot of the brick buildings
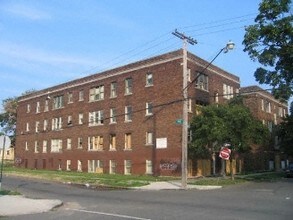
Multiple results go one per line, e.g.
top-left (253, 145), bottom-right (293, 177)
top-left (3, 164), bottom-right (284, 188)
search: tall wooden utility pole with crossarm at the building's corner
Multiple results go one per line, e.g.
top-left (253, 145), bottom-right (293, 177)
top-left (172, 29), bottom-right (197, 189)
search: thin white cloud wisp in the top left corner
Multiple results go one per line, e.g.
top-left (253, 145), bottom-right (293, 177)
top-left (1, 3), bottom-right (51, 20)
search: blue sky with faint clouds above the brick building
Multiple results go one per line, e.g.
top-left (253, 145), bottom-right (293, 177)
top-left (0, 0), bottom-right (282, 107)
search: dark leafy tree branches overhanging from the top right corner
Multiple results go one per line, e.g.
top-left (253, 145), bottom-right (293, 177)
top-left (243, 0), bottom-right (293, 100)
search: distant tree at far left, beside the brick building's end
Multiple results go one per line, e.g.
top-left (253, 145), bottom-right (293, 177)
top-left (0, 89), bottom-right (35, 146)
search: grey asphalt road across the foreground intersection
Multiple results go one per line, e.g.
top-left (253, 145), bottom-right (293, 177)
top-left (0, 176), bottom-right (293, 220)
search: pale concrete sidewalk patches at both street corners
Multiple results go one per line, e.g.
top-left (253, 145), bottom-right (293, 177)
top-left (0, 181), bottom-right (221, 217)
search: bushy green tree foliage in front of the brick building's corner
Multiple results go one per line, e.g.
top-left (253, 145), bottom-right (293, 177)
top-left (189, 100), bottom-right (269, 158)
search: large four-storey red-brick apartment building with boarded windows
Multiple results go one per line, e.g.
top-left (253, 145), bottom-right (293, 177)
top-left (15, 50), bottom-right (240, 175)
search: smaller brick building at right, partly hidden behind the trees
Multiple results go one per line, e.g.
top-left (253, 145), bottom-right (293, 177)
top-left (240, 86), bottom-right (288, 170)
